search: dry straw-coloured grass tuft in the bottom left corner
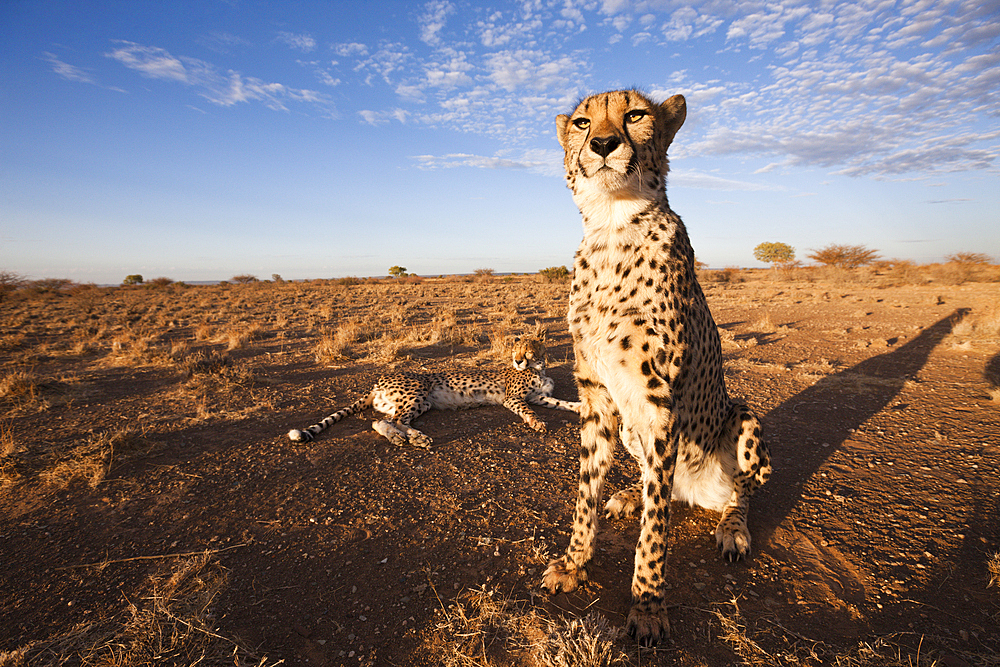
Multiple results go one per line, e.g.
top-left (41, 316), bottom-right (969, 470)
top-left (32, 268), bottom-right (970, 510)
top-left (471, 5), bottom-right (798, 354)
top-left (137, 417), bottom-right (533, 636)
top-left (0, 552), bottom-right (281, 667)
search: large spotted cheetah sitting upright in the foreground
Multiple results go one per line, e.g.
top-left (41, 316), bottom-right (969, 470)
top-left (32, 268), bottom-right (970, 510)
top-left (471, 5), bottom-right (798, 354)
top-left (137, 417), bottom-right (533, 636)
top-left (542, 90), bottom-right (771, 645)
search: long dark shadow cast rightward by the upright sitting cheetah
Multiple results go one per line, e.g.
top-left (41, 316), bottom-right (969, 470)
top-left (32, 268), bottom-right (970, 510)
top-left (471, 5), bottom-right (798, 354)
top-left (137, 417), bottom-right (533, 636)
top-left (756, 308), bottom-right (968, 544)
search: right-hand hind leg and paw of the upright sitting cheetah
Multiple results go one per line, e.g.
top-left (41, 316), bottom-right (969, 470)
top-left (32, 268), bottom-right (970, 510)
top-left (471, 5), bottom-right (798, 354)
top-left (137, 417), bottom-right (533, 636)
top-left (715, 402), bottom-right (771, 563)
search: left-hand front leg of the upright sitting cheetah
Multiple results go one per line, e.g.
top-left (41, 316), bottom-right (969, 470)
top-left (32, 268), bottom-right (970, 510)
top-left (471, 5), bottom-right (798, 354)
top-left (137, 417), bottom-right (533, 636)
top-left (542, 376), bottom-right (618, 593)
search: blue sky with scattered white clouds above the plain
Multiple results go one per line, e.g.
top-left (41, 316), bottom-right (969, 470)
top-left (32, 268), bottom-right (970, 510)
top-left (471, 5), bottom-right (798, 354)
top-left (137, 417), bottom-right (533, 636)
top-left (0, 0), bottom-right (1000, 283)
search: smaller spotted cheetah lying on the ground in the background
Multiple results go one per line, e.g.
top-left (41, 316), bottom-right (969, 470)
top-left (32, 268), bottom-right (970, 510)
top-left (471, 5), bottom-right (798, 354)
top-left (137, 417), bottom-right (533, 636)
top-left (288, 338), bottom-right (580, 448)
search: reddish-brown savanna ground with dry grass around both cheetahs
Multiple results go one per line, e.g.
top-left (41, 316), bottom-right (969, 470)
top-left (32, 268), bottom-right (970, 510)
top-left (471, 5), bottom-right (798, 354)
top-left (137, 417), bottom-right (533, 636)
top-left (0, 266), bottom-right (1000, 667)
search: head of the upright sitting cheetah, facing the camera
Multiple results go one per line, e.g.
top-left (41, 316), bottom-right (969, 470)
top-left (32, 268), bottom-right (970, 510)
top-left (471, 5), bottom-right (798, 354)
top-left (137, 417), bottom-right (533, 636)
top-left (556, 90), bottom-right (687, 198)
